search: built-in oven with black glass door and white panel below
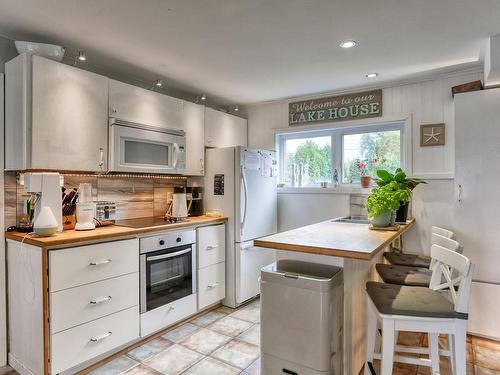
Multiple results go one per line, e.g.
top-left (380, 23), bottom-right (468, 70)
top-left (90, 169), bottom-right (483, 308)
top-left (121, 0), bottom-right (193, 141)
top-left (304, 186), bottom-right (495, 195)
top-left (139, 230), bottom-right (197, 337)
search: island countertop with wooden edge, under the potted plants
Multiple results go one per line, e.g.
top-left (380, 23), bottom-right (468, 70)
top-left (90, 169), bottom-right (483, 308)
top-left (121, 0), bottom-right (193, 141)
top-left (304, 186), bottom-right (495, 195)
top-left (254, 219), bottom-right (415, 260)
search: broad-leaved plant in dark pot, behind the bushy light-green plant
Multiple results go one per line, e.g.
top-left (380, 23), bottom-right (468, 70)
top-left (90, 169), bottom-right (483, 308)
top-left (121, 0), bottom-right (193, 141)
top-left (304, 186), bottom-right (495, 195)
top-left (374, 168), bottom-right (427, 222)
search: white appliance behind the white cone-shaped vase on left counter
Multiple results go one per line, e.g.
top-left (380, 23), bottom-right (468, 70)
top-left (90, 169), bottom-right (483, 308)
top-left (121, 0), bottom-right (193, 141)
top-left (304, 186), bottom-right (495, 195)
top-left (24, 172), bottom-right (63, 232)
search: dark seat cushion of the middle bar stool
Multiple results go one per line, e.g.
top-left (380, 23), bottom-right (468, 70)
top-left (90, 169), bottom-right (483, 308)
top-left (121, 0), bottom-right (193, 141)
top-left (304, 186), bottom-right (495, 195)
top-left (375, 264), bottom-right (432, 287)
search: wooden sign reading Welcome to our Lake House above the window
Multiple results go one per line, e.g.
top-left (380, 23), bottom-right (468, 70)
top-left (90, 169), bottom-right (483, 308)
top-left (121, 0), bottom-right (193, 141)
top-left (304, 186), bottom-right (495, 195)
top-left (288, 90), bottom-right (382, 125)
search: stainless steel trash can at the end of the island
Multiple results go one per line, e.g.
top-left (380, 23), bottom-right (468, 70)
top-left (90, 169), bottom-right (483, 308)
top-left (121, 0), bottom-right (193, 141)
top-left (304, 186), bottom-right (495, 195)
top-left (260, 260), bottom-right (343, 375)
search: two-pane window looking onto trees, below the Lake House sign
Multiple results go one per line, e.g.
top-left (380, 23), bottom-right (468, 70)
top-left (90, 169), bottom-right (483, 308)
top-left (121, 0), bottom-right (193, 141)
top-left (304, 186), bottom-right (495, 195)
top-left (277, 123), bottom-right (404, 186)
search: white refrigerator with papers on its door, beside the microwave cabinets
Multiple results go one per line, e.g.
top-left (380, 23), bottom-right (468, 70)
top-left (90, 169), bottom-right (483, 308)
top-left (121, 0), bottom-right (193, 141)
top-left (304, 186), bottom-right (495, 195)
top-left (204, 146), bottom-right (277, 308)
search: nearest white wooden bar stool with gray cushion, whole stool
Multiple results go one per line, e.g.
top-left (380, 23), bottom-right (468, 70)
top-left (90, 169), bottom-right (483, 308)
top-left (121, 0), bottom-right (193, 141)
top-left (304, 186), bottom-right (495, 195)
top-left (365, 245), bottom-right (474, 375)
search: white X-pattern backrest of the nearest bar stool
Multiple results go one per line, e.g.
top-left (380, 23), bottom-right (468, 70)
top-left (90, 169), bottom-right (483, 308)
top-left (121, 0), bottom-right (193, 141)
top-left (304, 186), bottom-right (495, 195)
top-left (429, 245), bottom-right (474, 313)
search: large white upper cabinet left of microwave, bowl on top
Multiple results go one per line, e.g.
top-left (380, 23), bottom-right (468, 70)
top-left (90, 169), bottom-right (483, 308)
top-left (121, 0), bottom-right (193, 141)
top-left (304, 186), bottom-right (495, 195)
top-left (5, 54), bottom-right (108, 172)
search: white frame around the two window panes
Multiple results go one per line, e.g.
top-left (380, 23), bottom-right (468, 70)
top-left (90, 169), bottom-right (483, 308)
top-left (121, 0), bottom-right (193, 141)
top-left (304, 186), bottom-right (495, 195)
top-left (276, 119), bottom-right (411, 189)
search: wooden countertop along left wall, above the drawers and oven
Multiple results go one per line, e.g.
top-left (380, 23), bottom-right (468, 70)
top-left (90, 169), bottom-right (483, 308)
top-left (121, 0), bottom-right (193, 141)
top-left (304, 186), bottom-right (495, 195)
top-left (5, 216), bottom-right (227, 249)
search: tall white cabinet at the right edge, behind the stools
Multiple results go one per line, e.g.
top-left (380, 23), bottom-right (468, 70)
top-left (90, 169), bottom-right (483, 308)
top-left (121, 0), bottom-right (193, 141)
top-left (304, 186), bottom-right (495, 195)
top-left (454, 89), bottom-right (500, 340)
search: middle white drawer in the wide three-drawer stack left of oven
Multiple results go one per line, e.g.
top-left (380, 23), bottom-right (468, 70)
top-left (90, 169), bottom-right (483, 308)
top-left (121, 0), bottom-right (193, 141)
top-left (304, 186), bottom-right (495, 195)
top-left (50, 272), bottom-right (139, 334)
